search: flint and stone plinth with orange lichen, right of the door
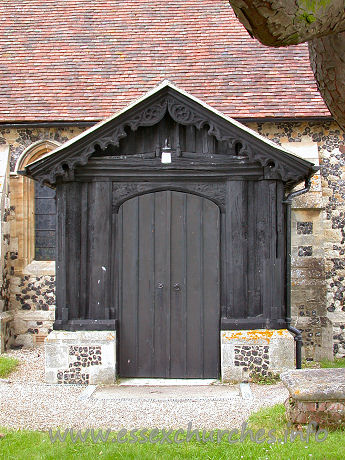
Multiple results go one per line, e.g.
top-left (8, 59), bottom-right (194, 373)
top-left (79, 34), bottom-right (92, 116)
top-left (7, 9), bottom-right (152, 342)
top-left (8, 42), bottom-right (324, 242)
top-left (220, 329), bottom-right (295, 382)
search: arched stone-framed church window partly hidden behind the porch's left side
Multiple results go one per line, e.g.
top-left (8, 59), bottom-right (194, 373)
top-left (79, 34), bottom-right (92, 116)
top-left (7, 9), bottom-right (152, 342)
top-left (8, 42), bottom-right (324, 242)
top-left (11, 141), bottom-right (60, 271)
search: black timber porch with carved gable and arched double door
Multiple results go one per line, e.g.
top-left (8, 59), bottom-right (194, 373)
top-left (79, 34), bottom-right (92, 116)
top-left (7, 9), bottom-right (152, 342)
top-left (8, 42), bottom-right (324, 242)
top-left (25, 83), bottom-right (314, 377)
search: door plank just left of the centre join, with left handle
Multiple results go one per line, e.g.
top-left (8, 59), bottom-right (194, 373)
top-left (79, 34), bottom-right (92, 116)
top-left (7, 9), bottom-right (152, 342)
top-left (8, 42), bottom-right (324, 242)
top-left (153, 192), bottom-right (171, 377)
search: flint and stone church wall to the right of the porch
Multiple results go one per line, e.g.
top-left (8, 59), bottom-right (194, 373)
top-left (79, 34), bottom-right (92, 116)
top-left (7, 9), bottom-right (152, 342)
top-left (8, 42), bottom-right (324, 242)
top-left (250, 121), bottom-right (345, 360)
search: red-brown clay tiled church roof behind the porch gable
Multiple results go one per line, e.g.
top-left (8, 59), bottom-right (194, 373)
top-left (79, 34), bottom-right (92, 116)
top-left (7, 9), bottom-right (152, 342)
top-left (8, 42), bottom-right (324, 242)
top-left (0, 0), bottom-right (329, 122)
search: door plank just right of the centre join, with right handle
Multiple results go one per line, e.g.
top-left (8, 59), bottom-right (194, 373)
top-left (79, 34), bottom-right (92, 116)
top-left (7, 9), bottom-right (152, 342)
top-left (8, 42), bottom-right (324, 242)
top-left (170, 192), bottom-right (187, 378)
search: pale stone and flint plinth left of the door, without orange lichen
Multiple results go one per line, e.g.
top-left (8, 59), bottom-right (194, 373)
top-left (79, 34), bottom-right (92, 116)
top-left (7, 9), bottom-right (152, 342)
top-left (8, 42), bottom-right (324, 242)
top-left (45, 331), bottom-right (116, 385)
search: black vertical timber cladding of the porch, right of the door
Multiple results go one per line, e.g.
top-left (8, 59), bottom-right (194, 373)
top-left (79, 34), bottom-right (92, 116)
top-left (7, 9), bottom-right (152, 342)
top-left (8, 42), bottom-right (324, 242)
top-left (224, 180), bottom-right (285, 327)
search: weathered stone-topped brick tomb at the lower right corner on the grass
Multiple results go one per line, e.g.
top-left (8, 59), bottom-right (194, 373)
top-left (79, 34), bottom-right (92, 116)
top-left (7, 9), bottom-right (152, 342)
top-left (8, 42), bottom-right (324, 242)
top-left (281, 369), bottom-right (345, 429)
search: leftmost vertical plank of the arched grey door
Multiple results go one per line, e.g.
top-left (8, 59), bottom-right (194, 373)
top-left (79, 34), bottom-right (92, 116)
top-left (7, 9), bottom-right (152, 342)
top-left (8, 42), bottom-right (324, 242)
top-left (120, 198), bottom-right (139, 377)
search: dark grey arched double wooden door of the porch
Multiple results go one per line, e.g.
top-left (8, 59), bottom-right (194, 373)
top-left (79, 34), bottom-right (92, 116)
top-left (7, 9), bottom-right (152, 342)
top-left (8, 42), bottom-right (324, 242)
top-left (117, 191), bottom-right (220, 378)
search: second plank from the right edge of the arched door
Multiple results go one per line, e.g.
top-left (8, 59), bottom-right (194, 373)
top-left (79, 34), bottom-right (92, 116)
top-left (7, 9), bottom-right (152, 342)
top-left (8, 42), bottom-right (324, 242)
top-left (187, 195), bottom-right (203, 378)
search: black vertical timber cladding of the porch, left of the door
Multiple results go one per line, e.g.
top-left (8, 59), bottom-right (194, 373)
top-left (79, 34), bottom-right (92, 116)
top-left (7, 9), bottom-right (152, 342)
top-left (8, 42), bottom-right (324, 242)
top-left (55, 182), bottom-right (114, 329)
